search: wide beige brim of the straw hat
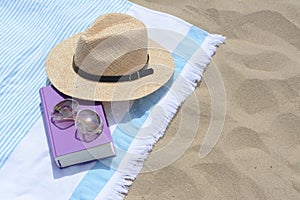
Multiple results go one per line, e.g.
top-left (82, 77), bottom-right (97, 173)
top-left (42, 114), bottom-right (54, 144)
top-left (46, 34), bottom-right (174, 101)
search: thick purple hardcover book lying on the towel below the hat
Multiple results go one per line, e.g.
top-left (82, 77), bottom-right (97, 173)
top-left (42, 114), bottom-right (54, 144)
top-left (39, 85), bottom-right (116, 168)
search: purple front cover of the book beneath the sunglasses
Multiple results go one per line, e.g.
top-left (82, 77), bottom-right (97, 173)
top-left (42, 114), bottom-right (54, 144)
top-left (40, 86), bottom-right (114, 167)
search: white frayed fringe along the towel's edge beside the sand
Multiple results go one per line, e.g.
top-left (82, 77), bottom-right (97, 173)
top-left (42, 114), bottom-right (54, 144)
top-left (105, 34), bottom-right (226, 200)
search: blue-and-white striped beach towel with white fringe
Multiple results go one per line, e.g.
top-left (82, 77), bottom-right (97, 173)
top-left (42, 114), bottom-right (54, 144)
top-left (0, 0), bottom-right (224, 200)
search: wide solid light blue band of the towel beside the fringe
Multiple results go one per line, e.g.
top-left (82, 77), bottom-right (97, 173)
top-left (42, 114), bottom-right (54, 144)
top-left (71, 26), bottom-right (207, 200)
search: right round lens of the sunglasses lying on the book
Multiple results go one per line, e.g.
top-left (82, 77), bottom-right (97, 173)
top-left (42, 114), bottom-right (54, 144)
top-left (75, 110), bottom-right (103, 142)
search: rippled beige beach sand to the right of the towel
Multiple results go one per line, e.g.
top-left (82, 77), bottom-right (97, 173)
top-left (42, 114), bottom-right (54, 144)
top-left (126, 0), bottom-right (300, 200)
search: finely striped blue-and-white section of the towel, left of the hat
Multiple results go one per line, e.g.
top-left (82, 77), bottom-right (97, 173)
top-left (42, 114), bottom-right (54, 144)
top-left (0, 0), bottom-right (132, 169)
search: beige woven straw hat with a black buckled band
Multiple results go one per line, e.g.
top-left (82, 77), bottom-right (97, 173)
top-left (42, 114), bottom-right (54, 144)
top-left (46, 13), bottom-right (174, 101)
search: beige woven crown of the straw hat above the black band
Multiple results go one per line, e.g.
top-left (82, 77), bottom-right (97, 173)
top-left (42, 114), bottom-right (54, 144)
top-left (74, 13), bottom-right (148, 76)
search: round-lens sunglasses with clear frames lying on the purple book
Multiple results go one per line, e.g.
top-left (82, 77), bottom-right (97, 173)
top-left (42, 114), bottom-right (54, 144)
top-left (51, 99), bottom-right (103, 142)
